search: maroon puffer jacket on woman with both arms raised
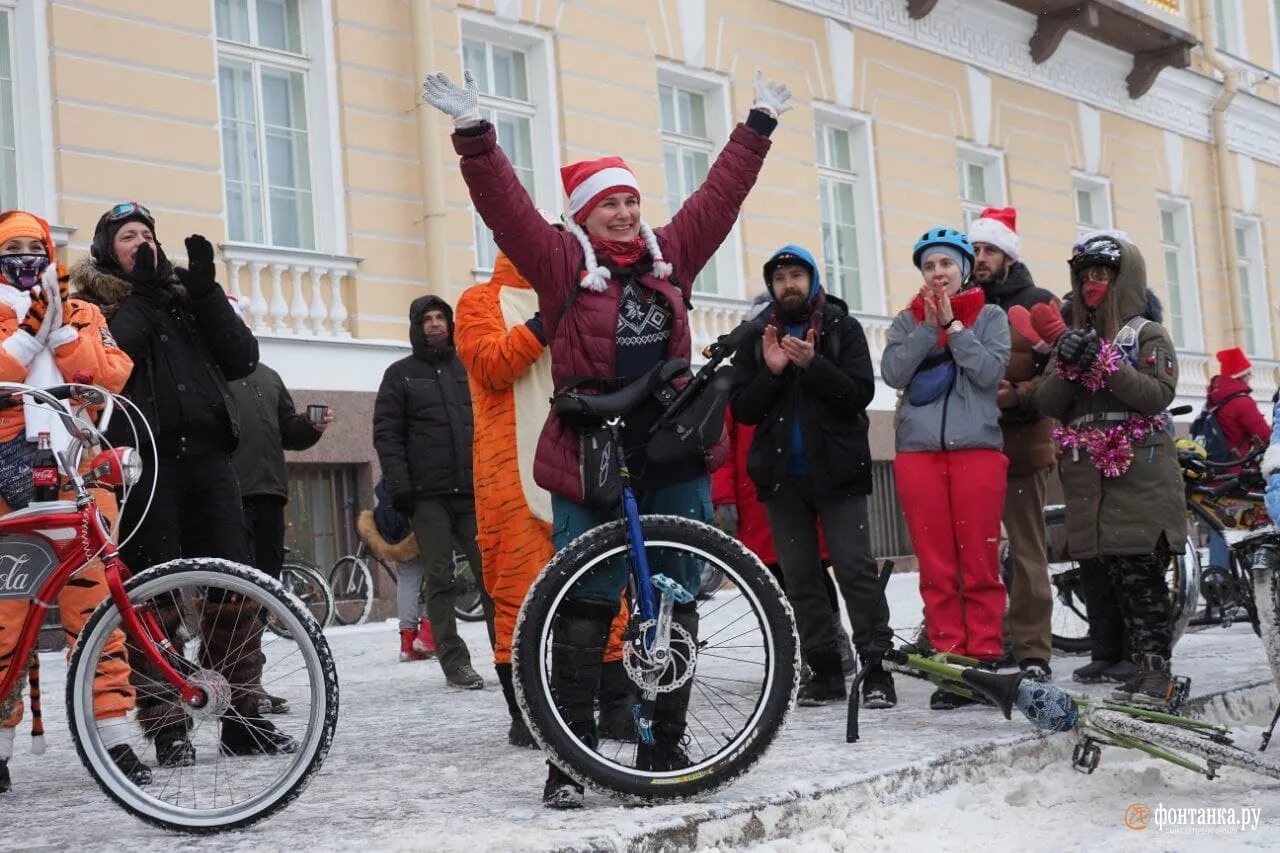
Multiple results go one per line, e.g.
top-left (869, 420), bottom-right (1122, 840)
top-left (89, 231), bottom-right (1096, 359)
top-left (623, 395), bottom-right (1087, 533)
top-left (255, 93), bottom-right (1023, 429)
top-left (453, 124), bottom-right (769, 502)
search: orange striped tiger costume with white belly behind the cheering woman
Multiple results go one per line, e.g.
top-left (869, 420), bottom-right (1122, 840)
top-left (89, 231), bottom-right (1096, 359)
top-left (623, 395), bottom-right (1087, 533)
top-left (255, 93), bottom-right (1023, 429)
top-left (453, 254), bottom-right (625, 663)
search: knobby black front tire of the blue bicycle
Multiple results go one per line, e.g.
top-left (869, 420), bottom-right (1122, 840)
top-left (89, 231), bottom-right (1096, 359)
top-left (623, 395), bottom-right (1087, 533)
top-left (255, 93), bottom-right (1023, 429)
top-left (512, 515), bottom-right (800, 803)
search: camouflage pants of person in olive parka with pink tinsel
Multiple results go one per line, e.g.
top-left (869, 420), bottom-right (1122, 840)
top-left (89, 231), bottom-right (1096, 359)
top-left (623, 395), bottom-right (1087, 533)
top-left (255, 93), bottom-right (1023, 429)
top-left (1080, 551), bottom-right (1172, 660)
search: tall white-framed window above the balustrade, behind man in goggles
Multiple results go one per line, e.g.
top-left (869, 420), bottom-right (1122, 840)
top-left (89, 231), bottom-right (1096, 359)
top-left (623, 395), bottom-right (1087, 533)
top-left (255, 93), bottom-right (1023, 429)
top-left (214, 0), bottom-right (316, 248)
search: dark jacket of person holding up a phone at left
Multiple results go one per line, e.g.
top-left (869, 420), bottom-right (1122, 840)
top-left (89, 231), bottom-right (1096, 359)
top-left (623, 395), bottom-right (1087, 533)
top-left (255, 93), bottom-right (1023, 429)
top-left (230, 362), bottom-right (323, 500)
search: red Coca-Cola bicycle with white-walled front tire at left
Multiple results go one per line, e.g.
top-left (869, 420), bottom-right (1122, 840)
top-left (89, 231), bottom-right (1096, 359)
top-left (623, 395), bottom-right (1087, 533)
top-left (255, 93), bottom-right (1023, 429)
top-left (0, 383), bottom-right (338, 833)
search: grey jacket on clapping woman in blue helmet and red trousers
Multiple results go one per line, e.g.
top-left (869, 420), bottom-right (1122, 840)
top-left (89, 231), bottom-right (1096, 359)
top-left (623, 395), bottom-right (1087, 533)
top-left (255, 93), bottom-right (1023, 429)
top-left (881, 305), bottom-right (1009, 453)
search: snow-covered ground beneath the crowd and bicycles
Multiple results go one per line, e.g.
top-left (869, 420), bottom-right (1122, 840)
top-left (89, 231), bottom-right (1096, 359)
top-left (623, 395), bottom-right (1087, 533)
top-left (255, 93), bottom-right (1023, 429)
top-left (0, 575), bottom-right (1280, 853)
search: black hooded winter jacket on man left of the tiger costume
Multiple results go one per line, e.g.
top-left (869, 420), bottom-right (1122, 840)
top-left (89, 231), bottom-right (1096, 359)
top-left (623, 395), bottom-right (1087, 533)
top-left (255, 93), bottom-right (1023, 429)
top-left (374, 296), bottom-right (472, 500)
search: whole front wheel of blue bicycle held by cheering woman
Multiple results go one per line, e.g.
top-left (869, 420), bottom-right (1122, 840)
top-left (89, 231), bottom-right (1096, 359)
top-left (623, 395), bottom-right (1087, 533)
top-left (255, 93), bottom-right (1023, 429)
top-left (512, 515), bottom-right (800, 802)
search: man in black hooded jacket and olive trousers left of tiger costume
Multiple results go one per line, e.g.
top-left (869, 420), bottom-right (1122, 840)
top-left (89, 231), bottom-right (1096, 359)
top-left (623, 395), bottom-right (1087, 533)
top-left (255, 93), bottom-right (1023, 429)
top-left (374, 296), bottom-right (493, 690)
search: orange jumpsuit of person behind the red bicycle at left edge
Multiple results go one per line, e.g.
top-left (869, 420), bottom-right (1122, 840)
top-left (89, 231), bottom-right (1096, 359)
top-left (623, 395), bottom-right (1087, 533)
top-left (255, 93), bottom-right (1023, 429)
top-left (0, 294), bottom-right (134, 729)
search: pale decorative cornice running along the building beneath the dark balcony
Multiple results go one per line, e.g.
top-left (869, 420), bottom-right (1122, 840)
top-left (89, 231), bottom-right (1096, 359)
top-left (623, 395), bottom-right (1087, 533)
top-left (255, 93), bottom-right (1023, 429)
top-left (778, 0), bottom-right (1280, 165)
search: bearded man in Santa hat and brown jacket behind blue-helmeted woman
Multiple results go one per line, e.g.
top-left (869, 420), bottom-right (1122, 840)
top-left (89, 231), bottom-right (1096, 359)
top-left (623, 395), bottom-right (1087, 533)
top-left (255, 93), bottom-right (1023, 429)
top-left (968, 207), bottom-right (1057, 681)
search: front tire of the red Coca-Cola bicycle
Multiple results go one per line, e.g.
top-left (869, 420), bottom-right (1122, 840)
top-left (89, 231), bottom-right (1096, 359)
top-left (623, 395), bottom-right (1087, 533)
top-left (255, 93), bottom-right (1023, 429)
top-left (67, 558), bottom-right (338, 835)
